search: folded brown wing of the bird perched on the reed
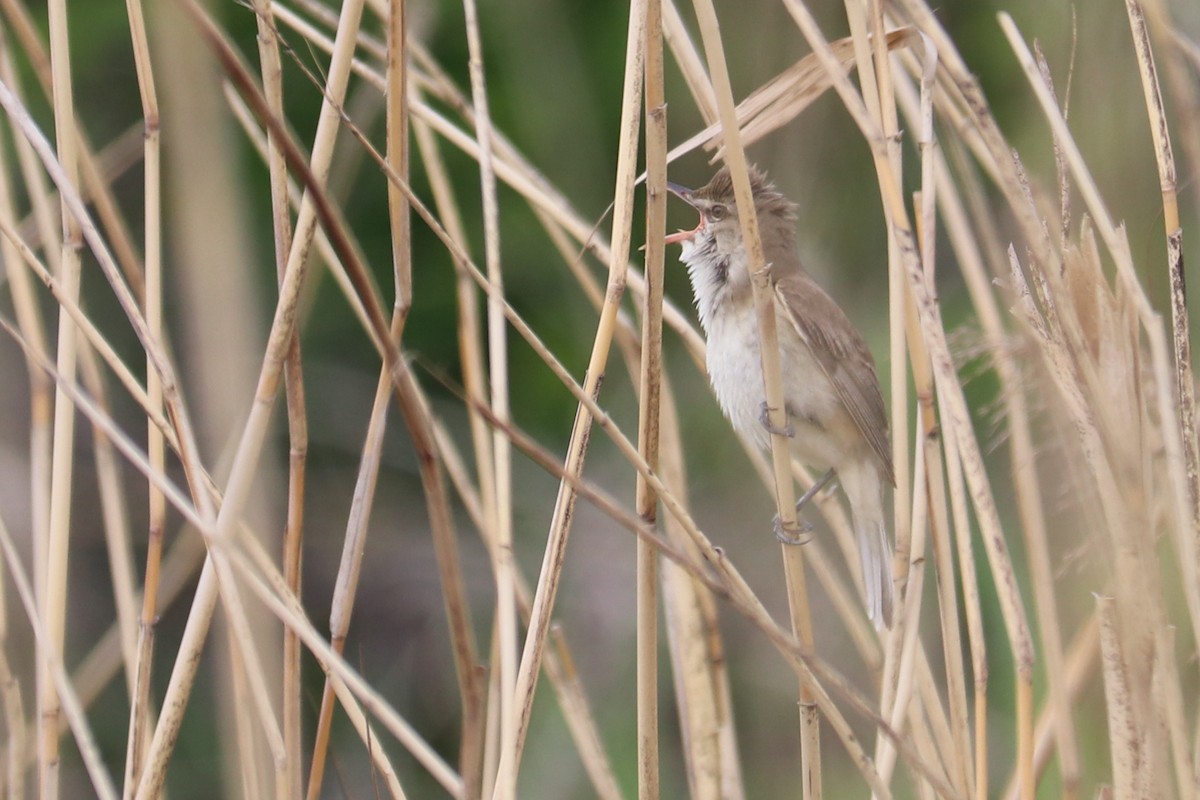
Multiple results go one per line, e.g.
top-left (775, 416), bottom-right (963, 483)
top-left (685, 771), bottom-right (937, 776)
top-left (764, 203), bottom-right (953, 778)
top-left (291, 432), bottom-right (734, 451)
top-left (774, 272), bottom-right (895, 486)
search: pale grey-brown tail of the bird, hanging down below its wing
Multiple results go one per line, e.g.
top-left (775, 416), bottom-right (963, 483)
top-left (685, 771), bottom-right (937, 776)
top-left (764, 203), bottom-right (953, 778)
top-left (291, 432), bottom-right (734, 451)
top-left (838, 464), bottom-right (895, 630)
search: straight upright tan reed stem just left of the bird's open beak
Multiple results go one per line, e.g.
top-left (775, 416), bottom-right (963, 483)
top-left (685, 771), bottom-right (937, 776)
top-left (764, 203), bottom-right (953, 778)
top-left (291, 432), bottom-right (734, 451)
top-left (634, 0), bottom-right (667, 800)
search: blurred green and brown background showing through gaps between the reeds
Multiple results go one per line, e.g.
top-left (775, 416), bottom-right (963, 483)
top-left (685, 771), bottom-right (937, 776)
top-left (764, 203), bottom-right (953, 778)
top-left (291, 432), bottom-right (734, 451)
top-left (0, 0), bottom-right (1200, 799)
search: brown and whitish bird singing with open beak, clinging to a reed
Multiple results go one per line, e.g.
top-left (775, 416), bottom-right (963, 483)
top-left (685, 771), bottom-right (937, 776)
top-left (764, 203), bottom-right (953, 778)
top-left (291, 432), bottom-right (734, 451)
top-left (666, 167), bottom-right (895, 630)
